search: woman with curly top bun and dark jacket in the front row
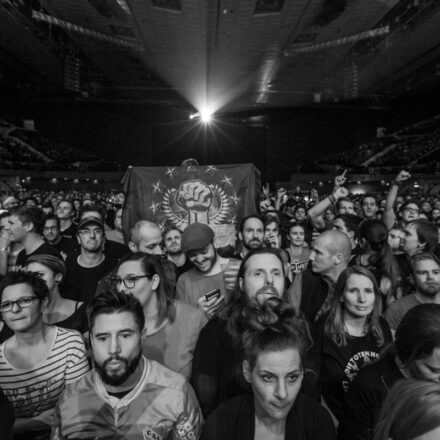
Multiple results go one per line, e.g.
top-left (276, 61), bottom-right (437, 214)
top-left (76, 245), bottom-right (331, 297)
top-left (201, 298), bottom-right (336, 440)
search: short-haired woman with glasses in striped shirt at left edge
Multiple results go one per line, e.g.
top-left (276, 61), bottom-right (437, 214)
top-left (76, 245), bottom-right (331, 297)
top-left (0, 272), bottom-right (89, 440)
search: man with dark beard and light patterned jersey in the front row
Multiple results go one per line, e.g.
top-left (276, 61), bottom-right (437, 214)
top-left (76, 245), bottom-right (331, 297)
top-left (52, 291), bottom-right (203, 440)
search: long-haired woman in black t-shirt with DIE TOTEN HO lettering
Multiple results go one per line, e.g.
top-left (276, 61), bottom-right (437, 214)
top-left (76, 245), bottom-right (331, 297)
top-left (313, 266), bottom-right (392, 420)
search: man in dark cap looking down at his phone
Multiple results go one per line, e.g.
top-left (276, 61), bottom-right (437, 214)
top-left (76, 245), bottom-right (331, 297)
top-left (176, 223), bottom-right (239, 317)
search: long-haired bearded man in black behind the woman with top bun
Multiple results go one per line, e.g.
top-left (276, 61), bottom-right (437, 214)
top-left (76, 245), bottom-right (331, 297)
top-left (191, 248), bottom-right (318, 417)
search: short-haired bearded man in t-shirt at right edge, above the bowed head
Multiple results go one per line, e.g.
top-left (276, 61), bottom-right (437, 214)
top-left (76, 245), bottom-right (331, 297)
top-left (384, 252), bottom-right (440, 332)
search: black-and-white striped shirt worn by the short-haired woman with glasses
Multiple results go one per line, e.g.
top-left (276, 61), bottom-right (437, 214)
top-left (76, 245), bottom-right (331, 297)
top-left (0, 327), bottom-right (89, 417)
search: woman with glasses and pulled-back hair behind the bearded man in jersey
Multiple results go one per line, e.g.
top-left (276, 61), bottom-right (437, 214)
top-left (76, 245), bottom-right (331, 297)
top-left (112, 252), bottom-right (207, 377)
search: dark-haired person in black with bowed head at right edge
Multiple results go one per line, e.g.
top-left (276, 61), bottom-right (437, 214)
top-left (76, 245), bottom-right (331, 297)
top-left (339, 304), bottom-right (440, 440)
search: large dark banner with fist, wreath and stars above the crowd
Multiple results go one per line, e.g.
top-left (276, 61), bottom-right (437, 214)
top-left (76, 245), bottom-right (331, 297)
top-left (122, 164), bottom-right (261, 247)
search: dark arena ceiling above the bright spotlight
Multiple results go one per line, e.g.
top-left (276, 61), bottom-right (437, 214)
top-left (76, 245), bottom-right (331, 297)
top-left (0, 0), bottom-right (440, 112)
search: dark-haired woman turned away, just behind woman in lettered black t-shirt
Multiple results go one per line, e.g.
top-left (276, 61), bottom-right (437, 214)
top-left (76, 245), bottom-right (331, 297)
top-left (356, 219), bottom-right (402, 306)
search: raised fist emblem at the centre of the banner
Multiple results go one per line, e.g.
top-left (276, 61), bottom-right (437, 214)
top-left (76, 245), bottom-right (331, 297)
top-left (177, 180), bottom-right (213, 223)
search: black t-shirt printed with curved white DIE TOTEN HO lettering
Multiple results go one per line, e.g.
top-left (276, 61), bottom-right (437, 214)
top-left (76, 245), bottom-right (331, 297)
top-left (312, 316), bottom-right (393, 420)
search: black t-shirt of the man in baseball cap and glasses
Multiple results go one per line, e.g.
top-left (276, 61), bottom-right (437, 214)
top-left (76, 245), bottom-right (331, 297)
top-left (62, 256), bottom-right (118, 302)
